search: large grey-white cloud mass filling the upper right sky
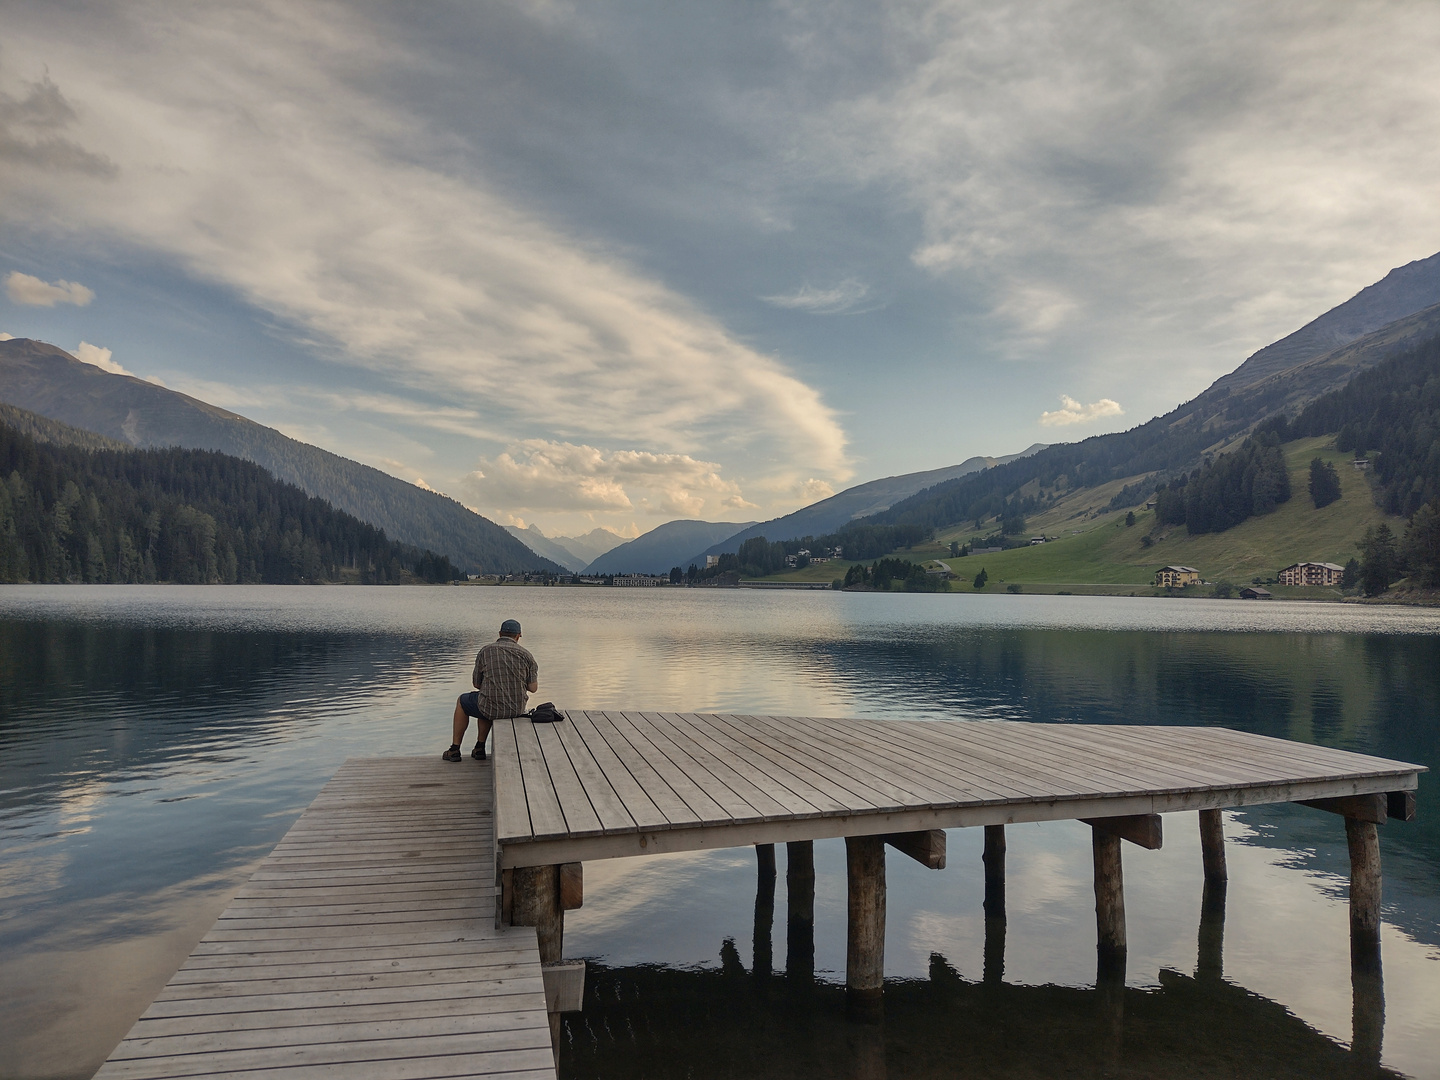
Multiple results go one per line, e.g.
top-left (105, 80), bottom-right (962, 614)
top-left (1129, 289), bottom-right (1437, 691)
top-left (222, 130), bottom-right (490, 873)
top-left (800, 0), bottom-right (1440, 377)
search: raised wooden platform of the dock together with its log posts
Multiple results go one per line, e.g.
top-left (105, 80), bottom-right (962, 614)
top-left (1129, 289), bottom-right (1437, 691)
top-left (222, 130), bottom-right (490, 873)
top-left (494, 720), bottom-right (1424, 1008)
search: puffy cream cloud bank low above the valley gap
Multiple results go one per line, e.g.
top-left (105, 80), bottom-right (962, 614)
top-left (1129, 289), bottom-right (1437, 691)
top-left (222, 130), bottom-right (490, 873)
top-left (462, 439), bottom-right (753, 518)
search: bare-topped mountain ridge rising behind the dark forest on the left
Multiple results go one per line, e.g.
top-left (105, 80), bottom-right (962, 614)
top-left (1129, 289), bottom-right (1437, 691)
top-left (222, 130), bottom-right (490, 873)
top-left (0, 338), bottom-right (560, 573)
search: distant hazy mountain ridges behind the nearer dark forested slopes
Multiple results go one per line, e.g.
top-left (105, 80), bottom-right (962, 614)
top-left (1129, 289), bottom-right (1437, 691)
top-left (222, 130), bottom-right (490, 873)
top-left (8, 253), bottom-right (1440, 573)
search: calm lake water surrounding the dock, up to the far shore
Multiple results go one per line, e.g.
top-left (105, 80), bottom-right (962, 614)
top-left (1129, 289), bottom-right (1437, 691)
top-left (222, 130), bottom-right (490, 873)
top-left (0, 586), bottom-right (1440, 1079)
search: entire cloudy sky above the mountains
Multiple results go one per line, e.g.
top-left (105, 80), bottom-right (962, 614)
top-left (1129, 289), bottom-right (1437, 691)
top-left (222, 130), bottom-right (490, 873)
top-left (0, 0), bottom-right (1440, 536)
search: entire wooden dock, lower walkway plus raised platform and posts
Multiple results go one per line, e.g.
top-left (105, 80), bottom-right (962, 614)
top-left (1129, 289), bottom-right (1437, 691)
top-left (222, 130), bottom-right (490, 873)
top-left (96, 710), bottom-right (1424, 1080)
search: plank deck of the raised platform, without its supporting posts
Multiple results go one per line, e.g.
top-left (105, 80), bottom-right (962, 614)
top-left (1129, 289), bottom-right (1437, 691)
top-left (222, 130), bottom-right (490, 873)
top-left (494, 710), bottom-right (1421, 867)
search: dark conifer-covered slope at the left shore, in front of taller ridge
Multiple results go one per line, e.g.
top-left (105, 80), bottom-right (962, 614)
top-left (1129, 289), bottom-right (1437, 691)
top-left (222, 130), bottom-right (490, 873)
top-left (0, 411), bottom-right (456, 585)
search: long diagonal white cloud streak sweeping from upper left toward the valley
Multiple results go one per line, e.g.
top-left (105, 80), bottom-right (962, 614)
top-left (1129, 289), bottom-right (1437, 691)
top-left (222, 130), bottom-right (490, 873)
top-left (0, 0), bottom-right (850, 500)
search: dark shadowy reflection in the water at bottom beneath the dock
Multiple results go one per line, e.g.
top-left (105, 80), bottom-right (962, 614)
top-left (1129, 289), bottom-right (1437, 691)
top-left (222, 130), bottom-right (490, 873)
top-left (560, 943), bottom-right (1400, 1080)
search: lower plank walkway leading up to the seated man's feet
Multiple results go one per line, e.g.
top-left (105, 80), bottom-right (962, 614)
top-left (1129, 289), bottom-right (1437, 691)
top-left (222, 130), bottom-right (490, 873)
top-left (96, 756), bottom-right (554, 1080)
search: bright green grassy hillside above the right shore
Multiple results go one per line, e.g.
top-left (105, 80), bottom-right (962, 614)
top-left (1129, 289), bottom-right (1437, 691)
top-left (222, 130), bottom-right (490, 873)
top-left (768, 436), bottom-right (1404, 596)
